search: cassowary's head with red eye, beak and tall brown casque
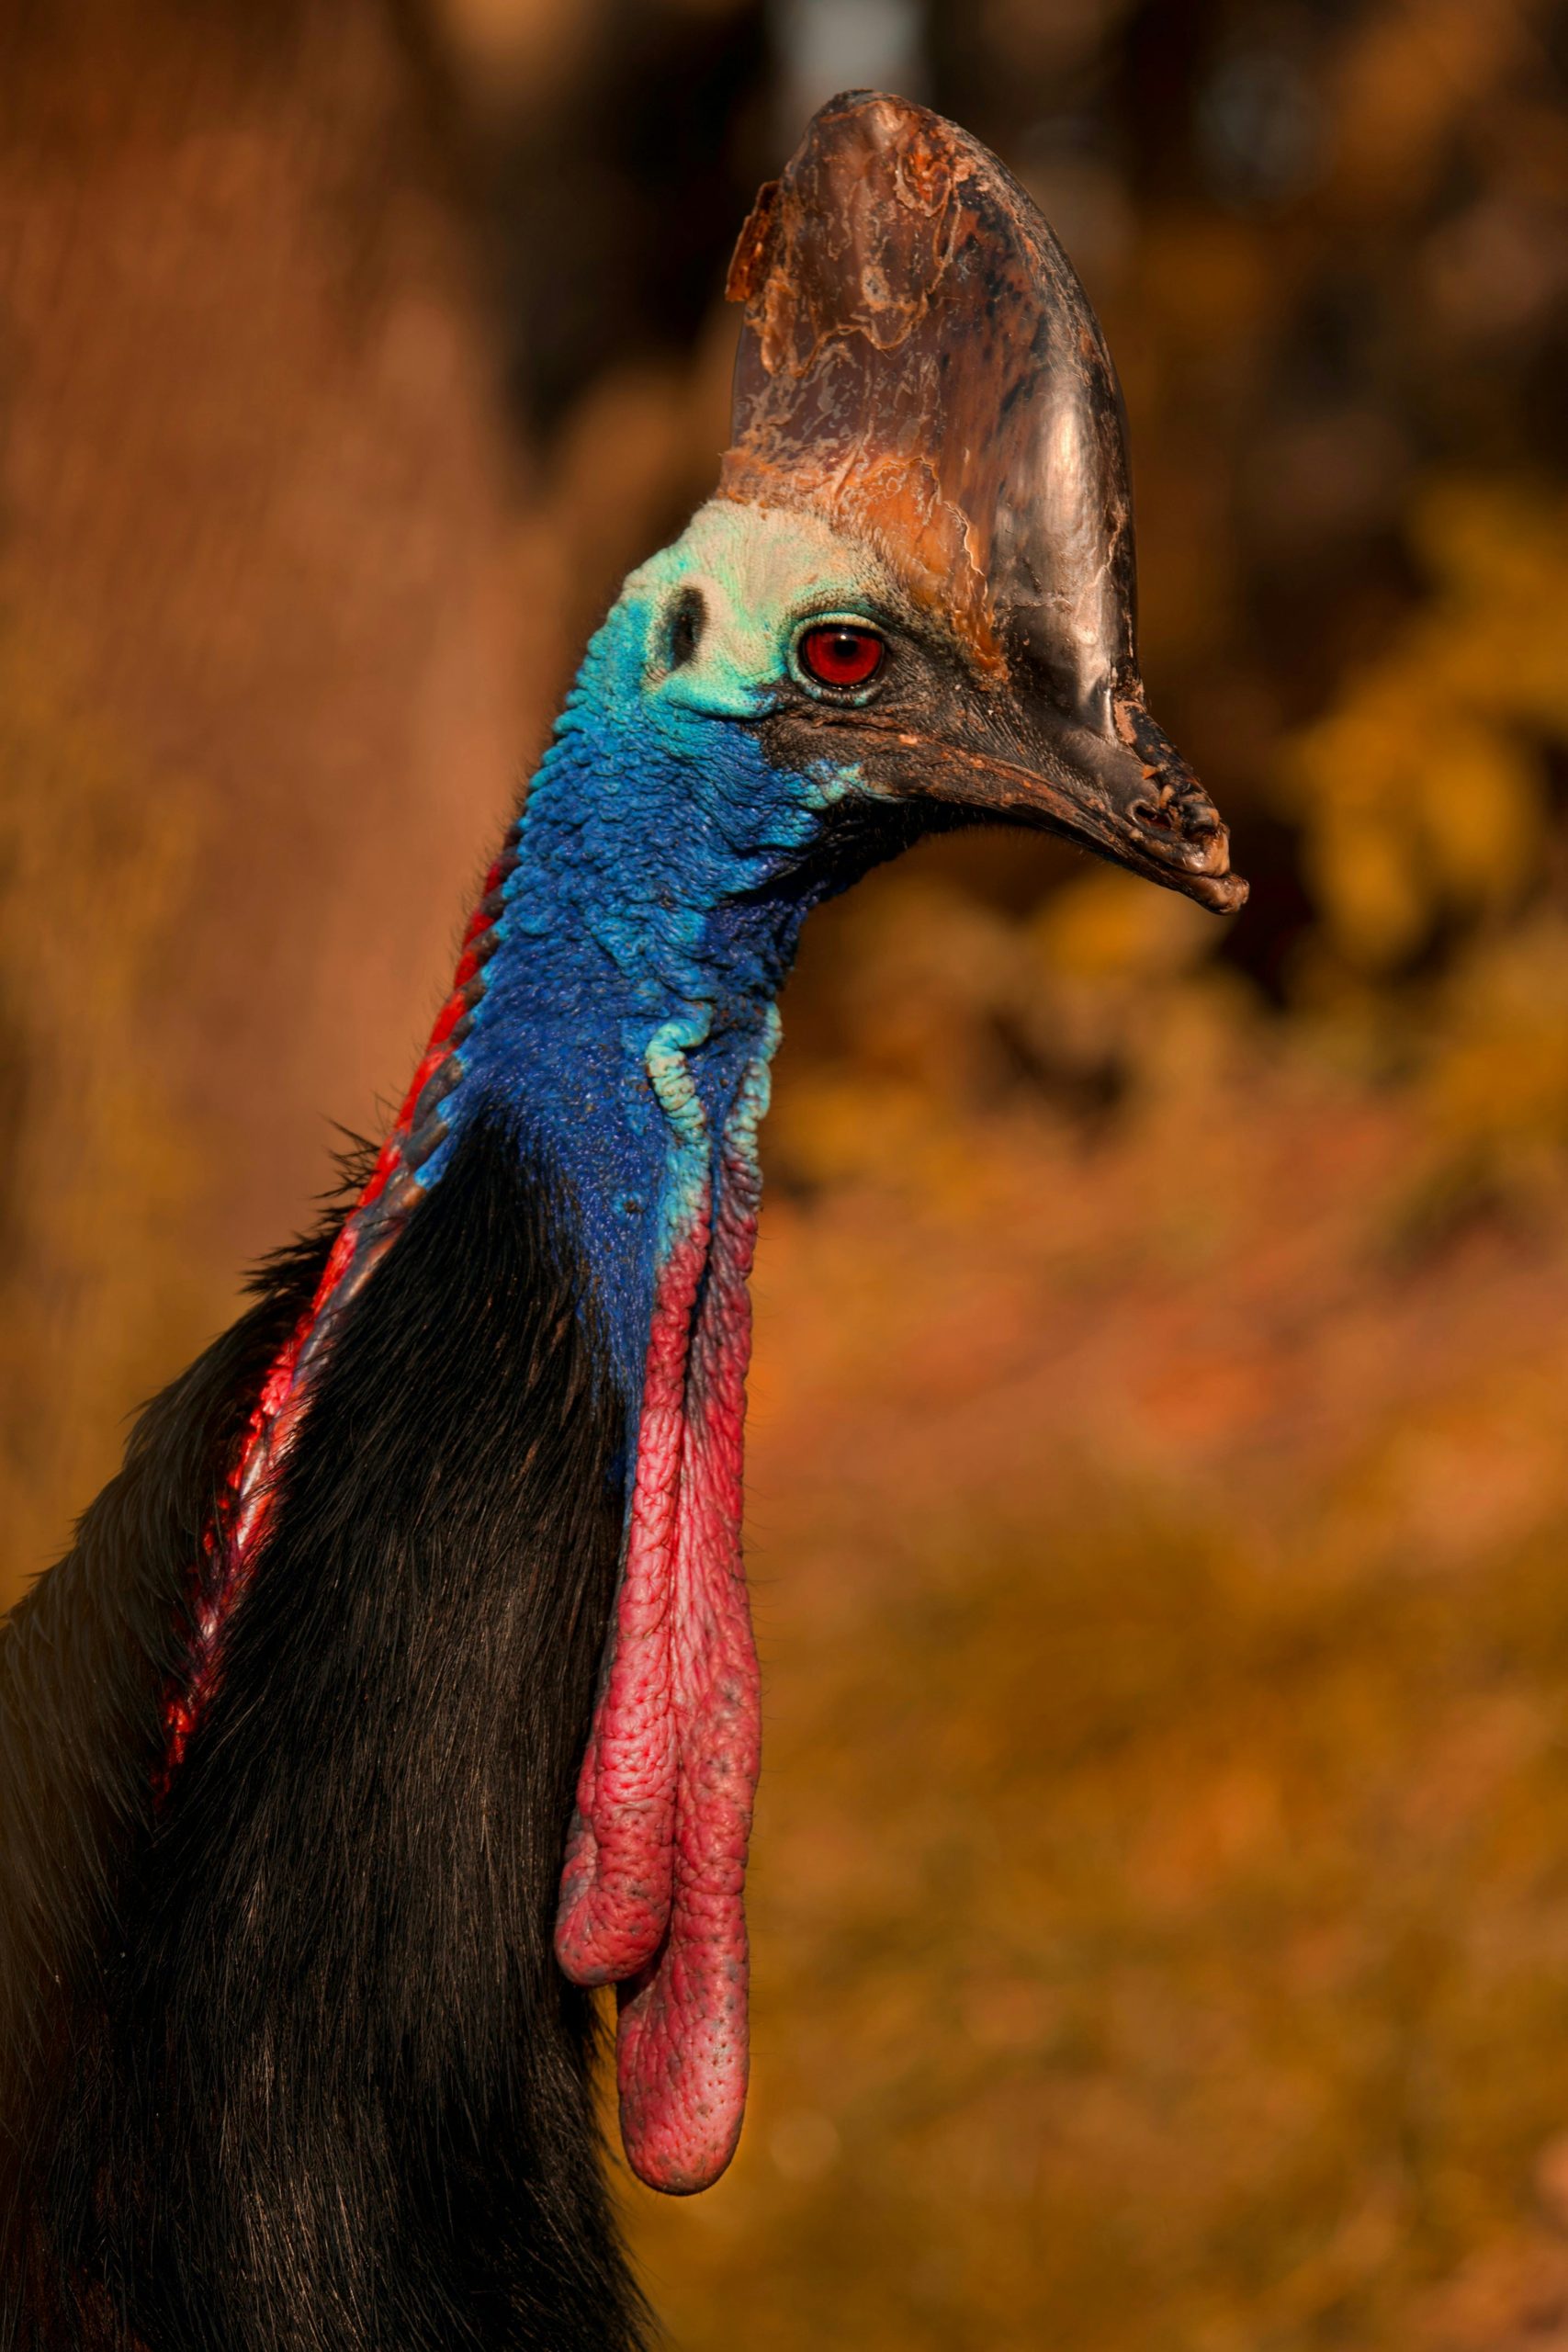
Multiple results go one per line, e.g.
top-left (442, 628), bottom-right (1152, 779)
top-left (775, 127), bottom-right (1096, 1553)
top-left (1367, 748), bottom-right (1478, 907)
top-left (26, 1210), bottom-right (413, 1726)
top-left (594, 94), bottom-right (1246, 912)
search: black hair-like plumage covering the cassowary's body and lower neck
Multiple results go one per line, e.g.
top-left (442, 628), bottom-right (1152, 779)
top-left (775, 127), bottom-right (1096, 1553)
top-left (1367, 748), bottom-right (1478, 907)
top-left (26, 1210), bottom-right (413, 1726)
top-left (0, 1126), bottom-right (647, 2352)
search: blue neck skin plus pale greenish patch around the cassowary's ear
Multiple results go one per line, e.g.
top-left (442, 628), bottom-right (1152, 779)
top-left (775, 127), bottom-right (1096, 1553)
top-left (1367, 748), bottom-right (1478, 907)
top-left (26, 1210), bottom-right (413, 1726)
top-left (419, 499), bottom-right (894, 1414)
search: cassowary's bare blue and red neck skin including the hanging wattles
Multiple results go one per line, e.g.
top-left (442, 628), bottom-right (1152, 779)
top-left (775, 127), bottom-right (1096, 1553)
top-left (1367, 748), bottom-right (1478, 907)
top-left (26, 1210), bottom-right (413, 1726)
top-left (164, 593), bottom-right (851, 2189)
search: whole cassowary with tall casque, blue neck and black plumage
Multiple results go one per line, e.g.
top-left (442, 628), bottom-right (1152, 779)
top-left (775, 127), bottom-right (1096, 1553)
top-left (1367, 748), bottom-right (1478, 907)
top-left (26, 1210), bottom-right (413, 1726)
top-left (0, 94), bottom-right (1244, 2352)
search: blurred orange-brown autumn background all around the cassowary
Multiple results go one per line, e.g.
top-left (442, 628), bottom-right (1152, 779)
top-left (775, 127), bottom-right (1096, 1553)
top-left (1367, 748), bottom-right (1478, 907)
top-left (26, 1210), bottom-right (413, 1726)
top-left (0, 0), bottom-right (1568, 2352)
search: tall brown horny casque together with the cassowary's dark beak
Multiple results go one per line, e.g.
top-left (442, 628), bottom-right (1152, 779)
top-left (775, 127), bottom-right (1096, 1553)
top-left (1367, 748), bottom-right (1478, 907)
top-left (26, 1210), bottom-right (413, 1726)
top-left (719, 92), bottom-right (1246, 912)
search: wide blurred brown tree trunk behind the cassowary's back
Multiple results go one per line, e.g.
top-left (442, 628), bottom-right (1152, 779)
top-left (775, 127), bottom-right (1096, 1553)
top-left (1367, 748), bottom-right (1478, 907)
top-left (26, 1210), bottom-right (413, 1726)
top-left (0, 0), bottom-right (522, 1600)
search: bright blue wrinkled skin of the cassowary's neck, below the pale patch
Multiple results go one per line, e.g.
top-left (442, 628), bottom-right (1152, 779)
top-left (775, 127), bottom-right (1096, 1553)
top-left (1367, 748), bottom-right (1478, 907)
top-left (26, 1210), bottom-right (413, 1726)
top-left (411, 597), bottom-right (835, 1404)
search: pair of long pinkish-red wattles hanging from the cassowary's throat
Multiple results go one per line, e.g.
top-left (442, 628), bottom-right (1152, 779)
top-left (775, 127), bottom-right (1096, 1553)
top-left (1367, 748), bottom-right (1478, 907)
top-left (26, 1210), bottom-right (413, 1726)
top-left (555, 1136), bottom-right (761, 2192)
